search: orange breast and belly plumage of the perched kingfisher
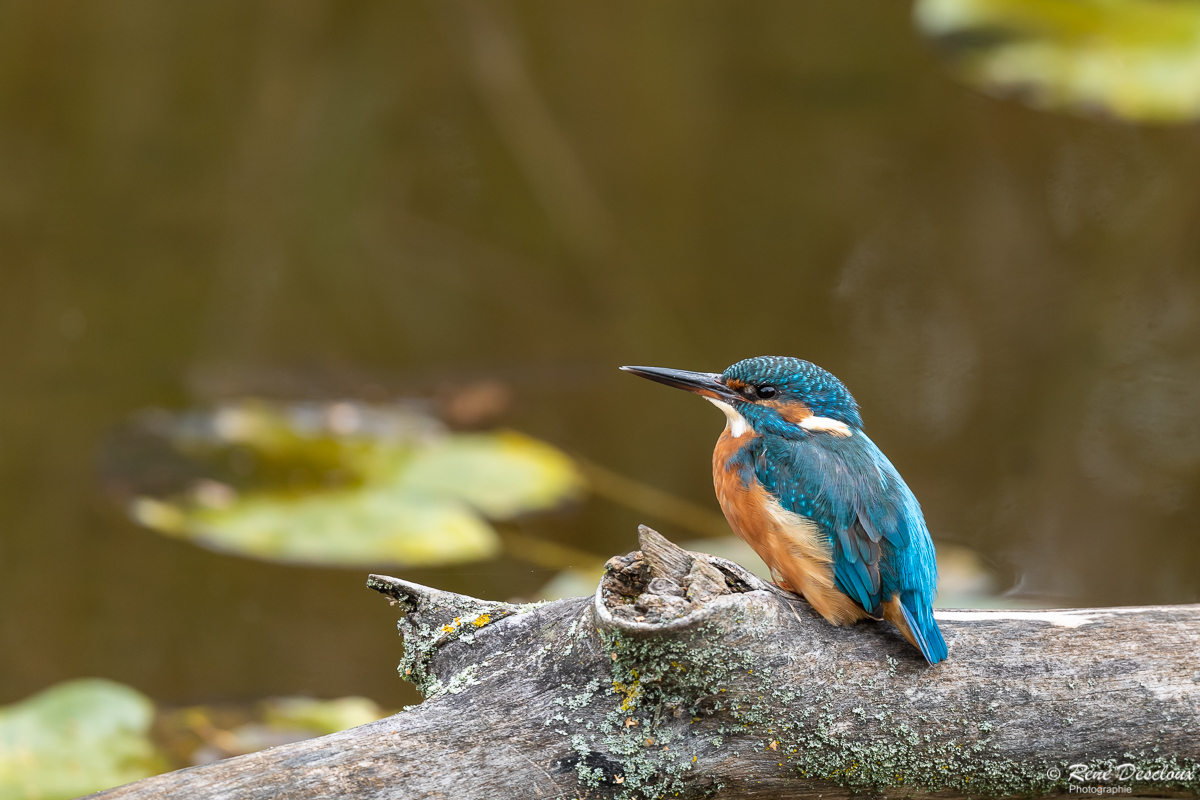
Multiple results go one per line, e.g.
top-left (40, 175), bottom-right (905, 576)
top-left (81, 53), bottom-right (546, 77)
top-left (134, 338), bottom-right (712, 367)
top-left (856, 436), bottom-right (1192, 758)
top-left (713, 427), bottom-right (868, 625)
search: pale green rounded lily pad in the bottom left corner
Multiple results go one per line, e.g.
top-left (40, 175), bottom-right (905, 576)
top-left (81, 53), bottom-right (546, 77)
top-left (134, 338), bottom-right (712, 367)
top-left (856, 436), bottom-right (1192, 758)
top-left (0, 678), bottom-right (163, 800)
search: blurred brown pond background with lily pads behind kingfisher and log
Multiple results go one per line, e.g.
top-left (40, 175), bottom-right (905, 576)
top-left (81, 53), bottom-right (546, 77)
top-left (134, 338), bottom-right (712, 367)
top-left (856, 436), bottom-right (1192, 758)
top-left (0, 0), bottom-right (1200, 798)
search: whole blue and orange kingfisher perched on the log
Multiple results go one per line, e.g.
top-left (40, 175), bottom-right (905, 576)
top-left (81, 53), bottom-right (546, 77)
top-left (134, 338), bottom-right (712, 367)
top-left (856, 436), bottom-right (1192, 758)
top-left (622, 356), bottom-right (947, 664)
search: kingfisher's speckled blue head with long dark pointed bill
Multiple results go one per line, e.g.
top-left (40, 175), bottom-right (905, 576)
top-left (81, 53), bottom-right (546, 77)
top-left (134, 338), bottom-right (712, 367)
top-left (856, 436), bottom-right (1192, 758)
top-left (622, 355), bottom-right (863, 438)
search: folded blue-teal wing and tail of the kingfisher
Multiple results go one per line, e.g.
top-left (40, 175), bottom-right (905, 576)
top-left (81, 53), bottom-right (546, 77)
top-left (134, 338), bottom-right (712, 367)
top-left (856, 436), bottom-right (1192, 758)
top-left (748, 431), bottom-right (946, 663)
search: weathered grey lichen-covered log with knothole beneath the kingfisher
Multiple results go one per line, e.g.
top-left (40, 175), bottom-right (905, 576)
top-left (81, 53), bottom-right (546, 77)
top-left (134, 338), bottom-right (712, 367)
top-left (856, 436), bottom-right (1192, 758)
top-left (96, 529), bottom-right (1200, 800)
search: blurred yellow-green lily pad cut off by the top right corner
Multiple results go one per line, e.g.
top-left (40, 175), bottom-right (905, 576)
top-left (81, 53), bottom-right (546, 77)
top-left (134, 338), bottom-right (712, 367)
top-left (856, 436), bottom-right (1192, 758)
top-left (914, 0), bottom-right (1200, 122)
